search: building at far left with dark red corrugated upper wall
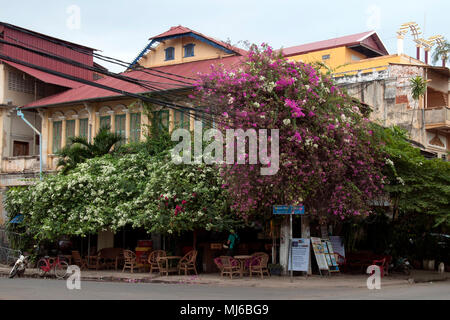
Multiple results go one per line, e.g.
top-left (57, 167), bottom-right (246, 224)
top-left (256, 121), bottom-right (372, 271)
top-left (0, 22), bottom-right (94, 225)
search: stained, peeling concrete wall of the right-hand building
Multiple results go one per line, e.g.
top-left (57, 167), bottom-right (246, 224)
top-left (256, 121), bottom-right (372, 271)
top-left (336, 65), bottom-right (450, 156)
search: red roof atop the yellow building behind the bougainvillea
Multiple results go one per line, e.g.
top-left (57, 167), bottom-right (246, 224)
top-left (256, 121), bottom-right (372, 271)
top-left (283, 31), bottom-right (389, 57)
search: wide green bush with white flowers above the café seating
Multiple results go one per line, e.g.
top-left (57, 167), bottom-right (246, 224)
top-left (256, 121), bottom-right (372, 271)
top-left (5, 152), bottom-right (236, 239)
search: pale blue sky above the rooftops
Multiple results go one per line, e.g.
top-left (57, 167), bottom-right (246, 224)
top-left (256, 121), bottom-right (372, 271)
top-left (0, 0), bottom-right (450, 71)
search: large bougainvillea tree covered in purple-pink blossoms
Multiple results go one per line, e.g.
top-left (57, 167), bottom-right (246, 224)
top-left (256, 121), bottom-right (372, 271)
top-left (196, 45), bottom-right (384, 219)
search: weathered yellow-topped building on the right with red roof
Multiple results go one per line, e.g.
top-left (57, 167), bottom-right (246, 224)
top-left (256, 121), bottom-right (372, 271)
top-left (282, 31), bottom-right (450, 159)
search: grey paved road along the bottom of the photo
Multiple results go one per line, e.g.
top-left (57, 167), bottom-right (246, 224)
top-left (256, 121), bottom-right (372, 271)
top-left (0, 278), bottom-right (450, 300)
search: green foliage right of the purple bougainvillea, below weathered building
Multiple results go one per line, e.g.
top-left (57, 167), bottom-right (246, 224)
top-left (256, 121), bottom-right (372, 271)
top-left (374, 125), bottom-right (450, 225)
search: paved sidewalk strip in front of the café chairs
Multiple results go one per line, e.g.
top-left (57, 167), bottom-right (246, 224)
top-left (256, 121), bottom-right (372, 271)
top-left (0, 265), bottom-right (450, 288)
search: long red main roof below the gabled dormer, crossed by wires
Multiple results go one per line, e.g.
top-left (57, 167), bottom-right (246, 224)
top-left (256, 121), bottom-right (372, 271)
top-left (23, 56), bottom-right (242, 108)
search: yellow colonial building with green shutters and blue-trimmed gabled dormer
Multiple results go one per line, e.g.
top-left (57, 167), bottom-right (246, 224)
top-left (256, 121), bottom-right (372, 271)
top-left (22, 26), bottom-right (245, 171)
